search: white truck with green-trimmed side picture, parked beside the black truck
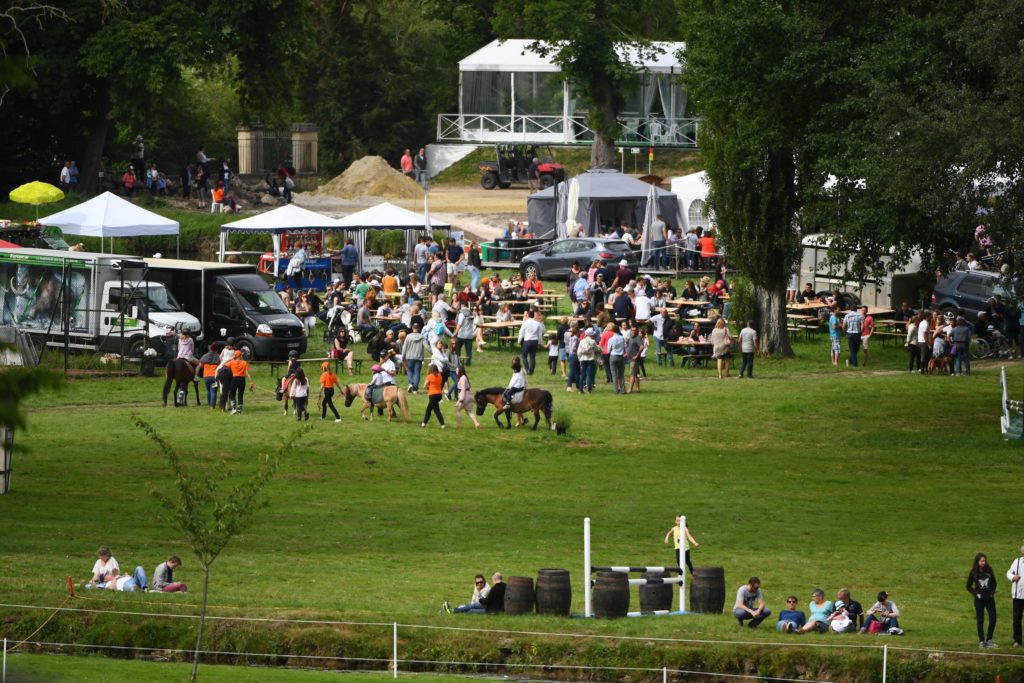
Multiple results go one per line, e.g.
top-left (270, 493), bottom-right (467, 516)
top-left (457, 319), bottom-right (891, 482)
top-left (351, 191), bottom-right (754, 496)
top-left (0, 248), bottom-right (202, 358)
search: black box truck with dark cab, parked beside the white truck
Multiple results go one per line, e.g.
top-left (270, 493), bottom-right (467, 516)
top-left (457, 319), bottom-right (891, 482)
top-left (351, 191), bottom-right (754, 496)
top-left (145, 258), bottom-right (307, 359)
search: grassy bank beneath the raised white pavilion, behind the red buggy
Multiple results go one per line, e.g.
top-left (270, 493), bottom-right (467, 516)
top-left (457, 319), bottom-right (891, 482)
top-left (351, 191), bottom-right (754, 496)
top-left (431, 145), bottom-right (702, 185)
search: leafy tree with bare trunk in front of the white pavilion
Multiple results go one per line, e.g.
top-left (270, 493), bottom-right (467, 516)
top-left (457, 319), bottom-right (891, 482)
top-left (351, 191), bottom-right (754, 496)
top-left (495, 0), bottom-right (677, 168)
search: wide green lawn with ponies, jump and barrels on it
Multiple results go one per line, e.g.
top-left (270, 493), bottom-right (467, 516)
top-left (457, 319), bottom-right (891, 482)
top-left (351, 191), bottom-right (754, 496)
top-left (0, 313), bottom-right (1024, 681)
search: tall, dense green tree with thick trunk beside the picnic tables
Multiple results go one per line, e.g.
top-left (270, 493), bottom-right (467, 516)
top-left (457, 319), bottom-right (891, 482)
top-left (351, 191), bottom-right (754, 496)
top-left (679, 0), bottom-right (869, 355)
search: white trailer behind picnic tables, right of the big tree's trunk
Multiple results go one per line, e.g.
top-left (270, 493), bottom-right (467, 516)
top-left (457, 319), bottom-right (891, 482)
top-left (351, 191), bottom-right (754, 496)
top-left (798, 233), bottom-right (922, 309)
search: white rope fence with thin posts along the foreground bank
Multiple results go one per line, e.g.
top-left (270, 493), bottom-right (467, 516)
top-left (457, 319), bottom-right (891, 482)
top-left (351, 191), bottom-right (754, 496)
top-left (6, 596), bottom-right (1024, 683)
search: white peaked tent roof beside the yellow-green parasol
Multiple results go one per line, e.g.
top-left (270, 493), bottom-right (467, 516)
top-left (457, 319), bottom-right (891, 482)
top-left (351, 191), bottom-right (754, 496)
top-left (39, 193), bottom-right (178, 238)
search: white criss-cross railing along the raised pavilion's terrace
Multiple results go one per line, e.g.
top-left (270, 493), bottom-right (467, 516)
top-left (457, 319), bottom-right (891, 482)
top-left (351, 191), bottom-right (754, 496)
top-left (437, 114), bottom-right (700, 147)
